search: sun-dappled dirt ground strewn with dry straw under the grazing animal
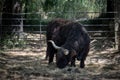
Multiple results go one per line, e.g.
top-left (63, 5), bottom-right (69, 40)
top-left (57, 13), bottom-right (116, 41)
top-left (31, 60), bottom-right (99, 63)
top-left (0, 33), bottom-right (120, 80)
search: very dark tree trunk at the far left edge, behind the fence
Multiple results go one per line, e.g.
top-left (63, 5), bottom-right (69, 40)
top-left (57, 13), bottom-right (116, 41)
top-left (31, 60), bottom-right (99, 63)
top-left (1, 0), bottom-right (12, 39)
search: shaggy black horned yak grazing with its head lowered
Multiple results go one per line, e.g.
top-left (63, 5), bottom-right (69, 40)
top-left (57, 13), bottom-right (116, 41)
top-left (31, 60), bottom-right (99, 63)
top-left (46, 19), bottom-right (90, 68)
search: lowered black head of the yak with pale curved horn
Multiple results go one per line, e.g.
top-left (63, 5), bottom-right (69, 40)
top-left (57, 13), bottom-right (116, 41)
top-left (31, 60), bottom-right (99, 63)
top-left (49, 40), bottom-right (70, 68)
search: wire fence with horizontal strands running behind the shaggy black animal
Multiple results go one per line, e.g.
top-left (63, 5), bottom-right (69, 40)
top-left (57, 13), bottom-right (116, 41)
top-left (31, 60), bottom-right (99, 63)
top-left (0, 12), bottom-right (118, 51)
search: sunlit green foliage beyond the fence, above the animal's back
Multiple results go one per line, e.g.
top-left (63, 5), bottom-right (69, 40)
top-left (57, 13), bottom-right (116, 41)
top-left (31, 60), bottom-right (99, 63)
top-left (22, 0), bottom-right (107, 30)
